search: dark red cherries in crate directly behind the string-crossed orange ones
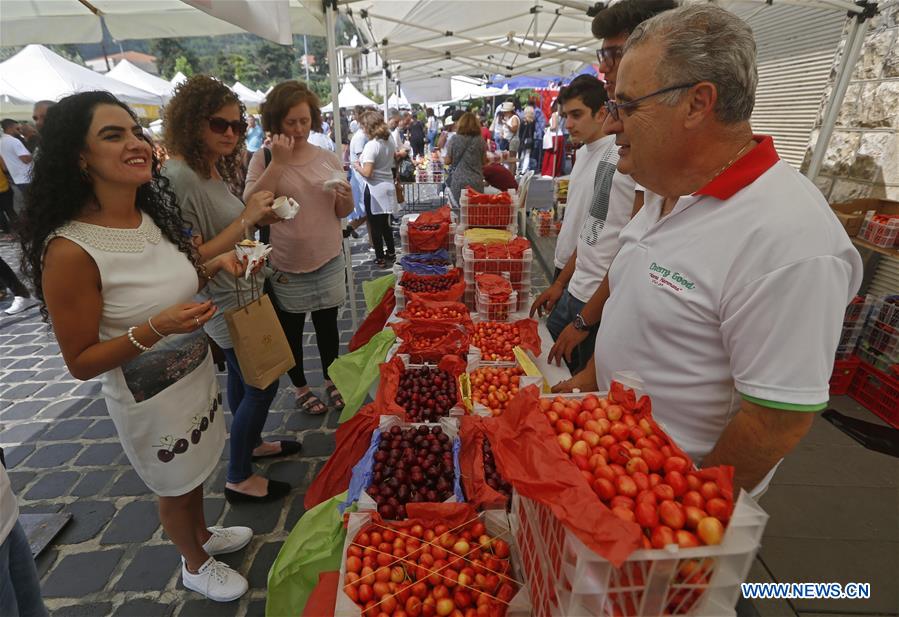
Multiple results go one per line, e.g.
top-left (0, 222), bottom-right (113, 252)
top-left (366, 426), bottom-right (454, 519)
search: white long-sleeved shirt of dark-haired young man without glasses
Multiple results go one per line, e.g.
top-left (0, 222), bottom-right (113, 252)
top-left (553, 135), bottom-right (617, 269)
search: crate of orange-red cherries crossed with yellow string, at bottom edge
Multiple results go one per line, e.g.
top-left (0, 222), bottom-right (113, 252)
top-left (334, 504), bottom-right (531, 617)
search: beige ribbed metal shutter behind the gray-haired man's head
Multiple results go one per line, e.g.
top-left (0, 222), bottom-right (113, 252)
top-left (728, 2), bottom-right (846, 169)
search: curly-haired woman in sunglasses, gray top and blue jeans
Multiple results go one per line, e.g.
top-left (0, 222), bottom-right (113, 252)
top-left (162, 75), bottom-right (300, 504)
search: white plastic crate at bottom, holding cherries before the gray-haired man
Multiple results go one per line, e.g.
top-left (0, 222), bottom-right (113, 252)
top-left (512, 492), bottom-right (768, 617)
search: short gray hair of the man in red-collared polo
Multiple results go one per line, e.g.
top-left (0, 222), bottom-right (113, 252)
top-left (624, 4), bottom-right (758, 124)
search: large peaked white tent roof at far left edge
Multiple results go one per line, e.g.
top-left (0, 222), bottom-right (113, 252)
top-left (0, 45), bottom-right (163, 111)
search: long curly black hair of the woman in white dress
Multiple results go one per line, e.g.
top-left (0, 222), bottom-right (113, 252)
top-left (17, 91), bottom-right (197, 321)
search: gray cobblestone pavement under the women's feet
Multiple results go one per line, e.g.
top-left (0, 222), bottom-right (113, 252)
top-left (0, 227), bottom-right (547, 617)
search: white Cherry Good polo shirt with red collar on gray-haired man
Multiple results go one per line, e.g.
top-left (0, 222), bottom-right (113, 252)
top-left (596, 136), bottom-right (862, 472)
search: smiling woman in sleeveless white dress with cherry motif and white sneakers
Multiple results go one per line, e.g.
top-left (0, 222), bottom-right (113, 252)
top-left (22, 92), bottom-right (253, 602)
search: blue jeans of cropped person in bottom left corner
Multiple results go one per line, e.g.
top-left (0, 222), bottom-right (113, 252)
top-left (0, 520), bottom-right (47, 617)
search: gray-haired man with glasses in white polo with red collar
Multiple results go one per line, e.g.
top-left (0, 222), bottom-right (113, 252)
top-left (560, 4), bottom-right (862, 494)
